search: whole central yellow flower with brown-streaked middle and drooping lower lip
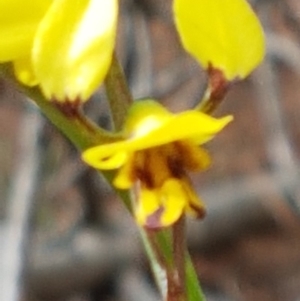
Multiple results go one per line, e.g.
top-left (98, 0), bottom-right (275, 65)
top-left (82, 100), bottom-right (232, 228)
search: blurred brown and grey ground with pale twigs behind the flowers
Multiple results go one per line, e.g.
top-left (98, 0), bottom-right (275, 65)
top-left (0, 0), bottom-right (300, 301)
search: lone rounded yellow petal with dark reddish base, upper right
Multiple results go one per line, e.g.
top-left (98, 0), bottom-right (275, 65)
top-left (173, 0), bottom-right (265, 81)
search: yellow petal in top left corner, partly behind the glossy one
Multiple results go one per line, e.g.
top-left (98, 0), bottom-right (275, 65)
top-left (0, 0), bottom-right (52, 62)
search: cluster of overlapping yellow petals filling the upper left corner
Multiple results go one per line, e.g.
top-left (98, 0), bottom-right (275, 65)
top-left (0, 0), bottom-right (118, 101)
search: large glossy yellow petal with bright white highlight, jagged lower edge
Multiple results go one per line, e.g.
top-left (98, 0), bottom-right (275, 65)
top-left (33, 0), bottom-right (118, 101)
